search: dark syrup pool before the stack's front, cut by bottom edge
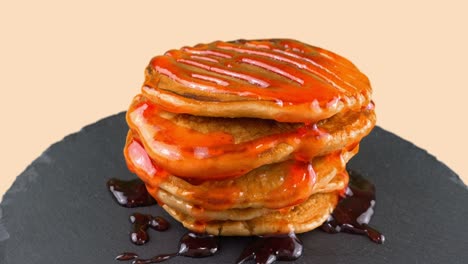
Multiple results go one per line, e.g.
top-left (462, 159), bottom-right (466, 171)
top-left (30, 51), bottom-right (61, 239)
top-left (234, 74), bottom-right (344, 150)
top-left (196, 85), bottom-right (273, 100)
top-left (236, 233), bottom-right (303, 264)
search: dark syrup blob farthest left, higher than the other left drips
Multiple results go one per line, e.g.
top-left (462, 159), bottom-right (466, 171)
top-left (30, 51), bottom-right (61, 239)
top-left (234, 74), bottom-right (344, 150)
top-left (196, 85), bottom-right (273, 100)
top-left (107, 179), bottom-right (156, 208)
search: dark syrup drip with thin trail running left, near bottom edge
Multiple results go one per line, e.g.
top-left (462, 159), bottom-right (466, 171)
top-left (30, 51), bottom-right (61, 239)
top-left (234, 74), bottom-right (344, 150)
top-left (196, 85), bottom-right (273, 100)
top-left (115, 232), bottom-right (219, 264)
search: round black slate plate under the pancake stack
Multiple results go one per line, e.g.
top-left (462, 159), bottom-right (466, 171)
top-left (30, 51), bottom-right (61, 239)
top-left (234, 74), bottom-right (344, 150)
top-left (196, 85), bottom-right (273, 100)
top-left (0, 113), bottom-right (468, 264)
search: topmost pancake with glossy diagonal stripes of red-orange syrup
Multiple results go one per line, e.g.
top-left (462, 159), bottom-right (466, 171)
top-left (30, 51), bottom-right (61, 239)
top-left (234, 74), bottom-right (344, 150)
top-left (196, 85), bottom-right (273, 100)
top-left (142, 39), bottom-right (371, 122)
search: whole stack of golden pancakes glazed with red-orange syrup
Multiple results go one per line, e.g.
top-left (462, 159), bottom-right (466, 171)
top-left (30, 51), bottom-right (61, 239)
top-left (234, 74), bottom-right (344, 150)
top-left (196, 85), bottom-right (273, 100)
top-left (124, 39), bottom-right (375, 236)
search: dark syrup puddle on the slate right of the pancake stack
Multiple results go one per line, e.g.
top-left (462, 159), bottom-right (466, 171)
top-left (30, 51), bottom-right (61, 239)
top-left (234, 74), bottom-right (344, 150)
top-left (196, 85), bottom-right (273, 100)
top-left (322, 171), bottom-right (385, 244)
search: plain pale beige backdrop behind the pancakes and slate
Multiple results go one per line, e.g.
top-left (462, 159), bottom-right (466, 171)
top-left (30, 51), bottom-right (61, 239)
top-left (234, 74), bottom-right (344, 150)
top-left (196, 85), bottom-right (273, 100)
top-left (0, 0), bottom-right (468, 195)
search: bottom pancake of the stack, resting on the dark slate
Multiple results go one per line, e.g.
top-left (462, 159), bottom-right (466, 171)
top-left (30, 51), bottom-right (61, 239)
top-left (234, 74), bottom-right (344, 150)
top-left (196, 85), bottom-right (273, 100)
top-left (163, 192), bottom-right (339, 236)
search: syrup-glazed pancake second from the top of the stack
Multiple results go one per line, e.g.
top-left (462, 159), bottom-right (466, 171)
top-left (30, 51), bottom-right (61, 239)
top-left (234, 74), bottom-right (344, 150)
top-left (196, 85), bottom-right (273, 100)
top-left (127, 95), bottom-right (375, 180)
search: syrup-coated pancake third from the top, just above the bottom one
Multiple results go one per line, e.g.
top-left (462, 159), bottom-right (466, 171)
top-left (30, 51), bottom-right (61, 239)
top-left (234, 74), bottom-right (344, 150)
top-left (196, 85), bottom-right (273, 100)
top-left (124, 132), bottom-right (357, 214)
